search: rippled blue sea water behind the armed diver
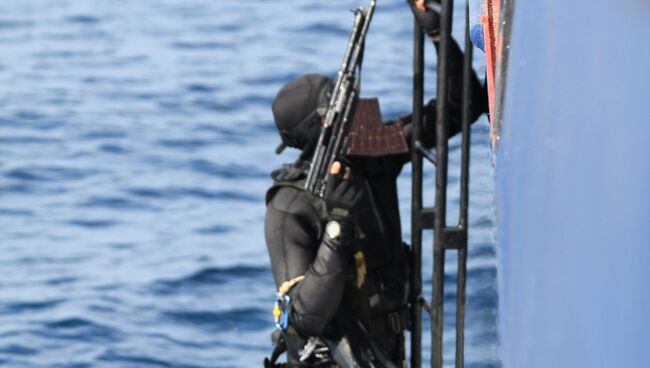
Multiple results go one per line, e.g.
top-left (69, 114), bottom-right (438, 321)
top-left (0, 0), bottom-right (499, 368)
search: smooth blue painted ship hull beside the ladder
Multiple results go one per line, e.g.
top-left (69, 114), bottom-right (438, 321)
top-left (478, 0), bottom-right (650, 368)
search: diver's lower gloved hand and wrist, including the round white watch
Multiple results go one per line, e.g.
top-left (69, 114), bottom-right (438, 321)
top-left (325, 161), bottom-right (366, 244)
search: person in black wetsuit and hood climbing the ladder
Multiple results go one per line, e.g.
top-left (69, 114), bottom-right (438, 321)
top-left (265, 2), bottom-right (487, 367)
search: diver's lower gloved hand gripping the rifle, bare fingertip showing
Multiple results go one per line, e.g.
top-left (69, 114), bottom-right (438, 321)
top-left (325, 161), bottom-right (366, 224)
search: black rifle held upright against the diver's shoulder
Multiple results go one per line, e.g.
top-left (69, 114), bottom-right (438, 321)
top-left (305, 0), bottom-right (377, 197)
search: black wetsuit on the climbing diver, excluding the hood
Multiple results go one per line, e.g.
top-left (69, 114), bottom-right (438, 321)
top-left (265, 38), bottom-right (487, 366)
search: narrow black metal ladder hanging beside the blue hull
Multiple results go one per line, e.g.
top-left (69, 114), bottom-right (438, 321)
top-left (411, 0), bottom-right (473, 368)
